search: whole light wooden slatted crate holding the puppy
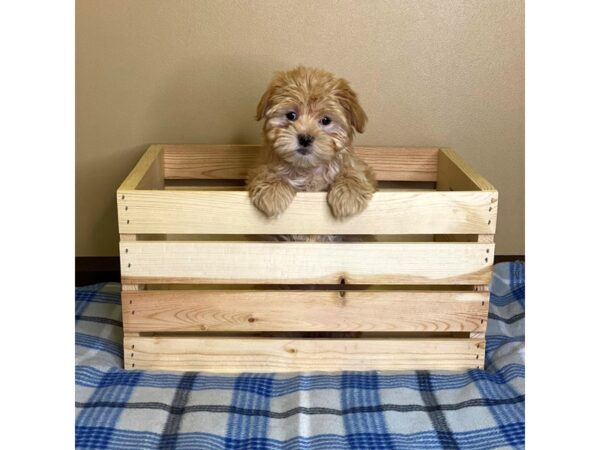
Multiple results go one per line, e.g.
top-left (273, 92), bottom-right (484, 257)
top-left (117, 144), bottom-right (498, 372)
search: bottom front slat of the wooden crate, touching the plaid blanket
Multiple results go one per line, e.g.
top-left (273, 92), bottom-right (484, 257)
top-left (124, 337), bottom-right (483, 373)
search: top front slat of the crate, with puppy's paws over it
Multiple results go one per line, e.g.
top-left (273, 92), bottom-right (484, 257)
top-left (118, 191), bottom-right (496, 234)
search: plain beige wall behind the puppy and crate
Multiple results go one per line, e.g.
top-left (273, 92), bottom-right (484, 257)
top-left (76, 0), bottom-right (524, 256)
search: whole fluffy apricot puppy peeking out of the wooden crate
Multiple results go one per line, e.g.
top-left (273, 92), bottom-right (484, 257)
top-left (247, 66), bottom-right (377, 219)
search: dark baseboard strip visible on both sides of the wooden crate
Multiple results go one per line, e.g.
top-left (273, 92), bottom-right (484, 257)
top-left (75, 255), bottom-right (525, 286)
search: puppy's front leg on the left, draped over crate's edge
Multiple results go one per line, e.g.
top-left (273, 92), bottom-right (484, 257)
top-left (248, 166), bottom-right (296, 217)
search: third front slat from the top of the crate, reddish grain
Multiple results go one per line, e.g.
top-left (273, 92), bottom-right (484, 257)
top-left (122, 291), bottom-right (488, 332)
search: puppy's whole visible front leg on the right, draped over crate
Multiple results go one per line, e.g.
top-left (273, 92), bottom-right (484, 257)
top-left (327, 162), bottom-right (377, 219)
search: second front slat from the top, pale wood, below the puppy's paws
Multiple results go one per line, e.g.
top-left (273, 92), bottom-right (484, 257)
top-left (120, 241), bottom-right (494, 284)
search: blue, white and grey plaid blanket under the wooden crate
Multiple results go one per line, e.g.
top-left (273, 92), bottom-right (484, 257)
top-left (75, 263), bottom-right (525, 450)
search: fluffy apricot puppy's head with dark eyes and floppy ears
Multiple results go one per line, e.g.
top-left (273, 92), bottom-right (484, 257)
top-left (256, 66), bottom-right (367, 168)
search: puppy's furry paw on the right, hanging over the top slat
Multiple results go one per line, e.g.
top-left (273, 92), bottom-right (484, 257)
top-left (327, 179), bottom-right (374, 219)
